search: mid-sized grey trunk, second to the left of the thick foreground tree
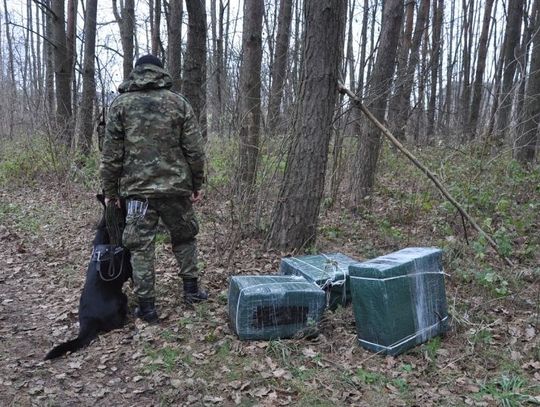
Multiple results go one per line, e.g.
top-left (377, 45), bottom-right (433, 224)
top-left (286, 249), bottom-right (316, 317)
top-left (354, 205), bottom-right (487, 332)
top-left (238, 0), bottom-right (264, 190)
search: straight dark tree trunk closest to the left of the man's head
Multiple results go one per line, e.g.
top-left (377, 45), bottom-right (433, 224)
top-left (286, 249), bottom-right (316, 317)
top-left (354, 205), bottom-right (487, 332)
top-left (79, 0), bottom-right (98, 155)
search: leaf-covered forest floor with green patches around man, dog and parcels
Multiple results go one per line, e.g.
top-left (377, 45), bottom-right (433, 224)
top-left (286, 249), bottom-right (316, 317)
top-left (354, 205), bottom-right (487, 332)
top-left (0, 145), bottom-right (540, 406)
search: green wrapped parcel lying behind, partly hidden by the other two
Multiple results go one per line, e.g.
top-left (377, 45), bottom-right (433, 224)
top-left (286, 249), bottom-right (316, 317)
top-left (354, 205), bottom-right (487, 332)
top-left (279, 253), bottom-right (357, 309)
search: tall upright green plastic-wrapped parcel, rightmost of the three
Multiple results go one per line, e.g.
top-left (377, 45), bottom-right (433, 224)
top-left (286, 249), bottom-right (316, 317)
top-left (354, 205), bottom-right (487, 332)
top-left (349, 248), bottom-right (448, 355)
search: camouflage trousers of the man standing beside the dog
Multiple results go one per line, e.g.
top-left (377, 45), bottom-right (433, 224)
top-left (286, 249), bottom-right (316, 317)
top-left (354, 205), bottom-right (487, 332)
top-left (122, 196), bottom-right (199, 299)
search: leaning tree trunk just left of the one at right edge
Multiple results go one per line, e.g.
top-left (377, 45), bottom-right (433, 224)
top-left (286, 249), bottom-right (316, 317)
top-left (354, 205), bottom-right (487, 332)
top-left (494, 0), bottom-right (524, 146)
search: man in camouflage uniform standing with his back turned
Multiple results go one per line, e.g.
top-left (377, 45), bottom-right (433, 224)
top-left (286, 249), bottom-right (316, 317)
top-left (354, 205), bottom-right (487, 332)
top-left (100, 55), bottom-right (208, 322)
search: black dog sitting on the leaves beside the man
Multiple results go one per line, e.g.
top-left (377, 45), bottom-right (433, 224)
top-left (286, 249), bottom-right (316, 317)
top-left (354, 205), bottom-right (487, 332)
top-left (45, 195), bottom-right (132, 360)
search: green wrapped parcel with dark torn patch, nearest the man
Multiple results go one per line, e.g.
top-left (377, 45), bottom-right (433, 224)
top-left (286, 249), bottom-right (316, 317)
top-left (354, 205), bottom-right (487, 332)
top-left (228, 276), bottom-right (325, 340)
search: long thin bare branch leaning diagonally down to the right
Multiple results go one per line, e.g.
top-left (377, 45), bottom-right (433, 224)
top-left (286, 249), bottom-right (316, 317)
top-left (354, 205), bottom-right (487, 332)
top-left (338, 82), bottom-right (513, 266)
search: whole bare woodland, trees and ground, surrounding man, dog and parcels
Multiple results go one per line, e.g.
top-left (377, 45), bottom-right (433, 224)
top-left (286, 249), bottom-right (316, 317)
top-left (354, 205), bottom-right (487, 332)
top-left (0, 0), bottom-right (540, 406)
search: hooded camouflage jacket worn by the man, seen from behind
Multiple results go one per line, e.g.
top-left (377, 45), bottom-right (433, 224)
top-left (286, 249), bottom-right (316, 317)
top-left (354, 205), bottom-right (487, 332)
top-left (100, 64), bottom-right (204, 198)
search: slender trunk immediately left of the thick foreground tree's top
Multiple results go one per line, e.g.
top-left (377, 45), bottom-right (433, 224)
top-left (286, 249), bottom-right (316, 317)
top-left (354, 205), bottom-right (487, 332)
top-left (268, 0), bottom-right (292, 133)
